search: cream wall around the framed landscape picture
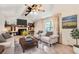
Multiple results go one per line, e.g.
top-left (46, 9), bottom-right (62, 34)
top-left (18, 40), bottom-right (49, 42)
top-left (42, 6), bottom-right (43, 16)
top-left (53, 4), bottom-right (79, 45)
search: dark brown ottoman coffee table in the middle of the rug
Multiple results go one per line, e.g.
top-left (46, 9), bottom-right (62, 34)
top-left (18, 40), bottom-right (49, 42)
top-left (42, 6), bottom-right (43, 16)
top-left (19, 38), bottom-right (38, 52)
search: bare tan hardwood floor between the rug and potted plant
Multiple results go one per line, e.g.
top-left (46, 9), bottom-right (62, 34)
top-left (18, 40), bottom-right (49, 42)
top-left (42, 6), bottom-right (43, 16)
top-left (54, 44), bottom-right (74, 54)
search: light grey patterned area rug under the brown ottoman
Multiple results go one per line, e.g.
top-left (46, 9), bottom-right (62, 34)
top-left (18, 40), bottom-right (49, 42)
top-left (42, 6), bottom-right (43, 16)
top-left (15, 40), bottom-right (56, 54)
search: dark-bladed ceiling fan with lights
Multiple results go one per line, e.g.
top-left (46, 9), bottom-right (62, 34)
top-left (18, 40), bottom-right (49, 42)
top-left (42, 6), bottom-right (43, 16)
top-left (24, 4), bottom-right (45, 16)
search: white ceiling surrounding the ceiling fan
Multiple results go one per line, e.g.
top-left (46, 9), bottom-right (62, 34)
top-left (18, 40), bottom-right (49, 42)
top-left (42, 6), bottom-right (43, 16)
top-left (0, 4), bottom-right (53, 23)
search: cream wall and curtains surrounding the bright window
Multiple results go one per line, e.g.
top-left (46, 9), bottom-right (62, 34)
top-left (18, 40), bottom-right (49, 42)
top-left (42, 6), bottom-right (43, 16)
top-left (34, 15), bottom-right (58, 35)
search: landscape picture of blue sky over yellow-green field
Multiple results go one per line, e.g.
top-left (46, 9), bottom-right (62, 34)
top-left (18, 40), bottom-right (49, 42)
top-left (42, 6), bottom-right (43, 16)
top-left (62, 15), bottom-right (77, 29)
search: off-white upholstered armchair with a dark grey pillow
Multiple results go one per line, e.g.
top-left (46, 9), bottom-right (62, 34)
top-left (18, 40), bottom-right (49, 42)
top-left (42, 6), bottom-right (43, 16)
top-left (41, 32), bottom-right (58, 47)
